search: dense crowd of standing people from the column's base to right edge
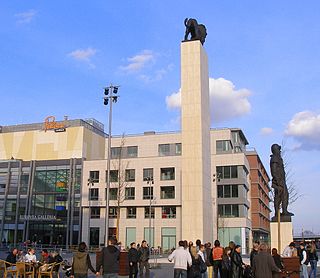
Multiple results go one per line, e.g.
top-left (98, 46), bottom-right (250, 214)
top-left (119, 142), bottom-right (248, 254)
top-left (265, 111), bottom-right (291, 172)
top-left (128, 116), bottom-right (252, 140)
top-left (168, 240), bottom-right (318, 278)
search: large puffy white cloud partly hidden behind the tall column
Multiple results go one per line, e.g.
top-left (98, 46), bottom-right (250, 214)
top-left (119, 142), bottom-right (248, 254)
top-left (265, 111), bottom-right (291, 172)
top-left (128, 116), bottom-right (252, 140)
top-left (166, 78), bottom-right (251, 122)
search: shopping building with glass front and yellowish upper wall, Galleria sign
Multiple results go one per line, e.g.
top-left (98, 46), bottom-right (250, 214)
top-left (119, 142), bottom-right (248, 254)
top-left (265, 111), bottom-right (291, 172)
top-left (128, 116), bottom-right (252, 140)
top-left (0, 117), bottom-right (105, 245)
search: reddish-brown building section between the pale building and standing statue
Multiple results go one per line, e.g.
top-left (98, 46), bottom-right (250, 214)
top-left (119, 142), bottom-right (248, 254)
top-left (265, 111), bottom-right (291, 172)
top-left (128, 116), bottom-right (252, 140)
top-left (246, 150), bottom-right (271, 243)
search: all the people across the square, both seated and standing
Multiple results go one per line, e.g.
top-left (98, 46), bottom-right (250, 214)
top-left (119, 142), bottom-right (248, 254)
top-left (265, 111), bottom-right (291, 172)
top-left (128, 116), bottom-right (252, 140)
top-left (1, 237), bottom-right (318, 278)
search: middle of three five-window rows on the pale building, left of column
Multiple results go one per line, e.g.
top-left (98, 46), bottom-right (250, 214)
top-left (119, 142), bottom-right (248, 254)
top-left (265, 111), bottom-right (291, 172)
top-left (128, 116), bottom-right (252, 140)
top-left (89, 186), bottom-right (175, 201)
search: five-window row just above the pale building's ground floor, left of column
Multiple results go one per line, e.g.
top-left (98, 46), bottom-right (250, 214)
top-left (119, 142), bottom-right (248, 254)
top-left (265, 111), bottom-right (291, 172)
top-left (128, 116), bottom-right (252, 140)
top-left (90, 206), bottom-right (176, 219)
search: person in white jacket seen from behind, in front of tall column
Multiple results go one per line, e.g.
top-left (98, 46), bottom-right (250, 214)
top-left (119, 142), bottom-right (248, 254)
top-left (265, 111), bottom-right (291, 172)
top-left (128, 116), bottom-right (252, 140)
top-left (168, 240), bottom-right (192, 278)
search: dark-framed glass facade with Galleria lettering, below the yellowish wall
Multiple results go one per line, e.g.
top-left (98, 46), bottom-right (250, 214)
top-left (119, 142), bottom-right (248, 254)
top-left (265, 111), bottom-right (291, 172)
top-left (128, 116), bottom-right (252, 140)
top-left (0, 159), bottom-right (82, 245)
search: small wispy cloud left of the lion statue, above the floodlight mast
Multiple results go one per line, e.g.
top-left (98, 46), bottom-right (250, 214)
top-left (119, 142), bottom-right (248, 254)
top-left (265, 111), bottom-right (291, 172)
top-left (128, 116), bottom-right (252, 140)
top-left (119, 50), bottom-right (155, 73)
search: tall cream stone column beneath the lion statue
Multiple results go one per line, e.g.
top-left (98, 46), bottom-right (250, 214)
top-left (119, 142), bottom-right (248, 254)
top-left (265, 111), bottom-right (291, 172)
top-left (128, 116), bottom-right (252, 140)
top-left (181, 41), bottom-right (213, 241)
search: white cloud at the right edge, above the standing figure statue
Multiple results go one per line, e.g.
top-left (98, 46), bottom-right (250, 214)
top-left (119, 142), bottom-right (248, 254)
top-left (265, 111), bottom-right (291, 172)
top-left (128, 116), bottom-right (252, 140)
top-left (285, 111), bottom-right (320, 150)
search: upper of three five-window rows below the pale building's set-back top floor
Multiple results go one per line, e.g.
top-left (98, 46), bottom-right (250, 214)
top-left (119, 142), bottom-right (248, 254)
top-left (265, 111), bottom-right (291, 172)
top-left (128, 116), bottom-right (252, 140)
top-left (89, 167), bottom-right (175, 183)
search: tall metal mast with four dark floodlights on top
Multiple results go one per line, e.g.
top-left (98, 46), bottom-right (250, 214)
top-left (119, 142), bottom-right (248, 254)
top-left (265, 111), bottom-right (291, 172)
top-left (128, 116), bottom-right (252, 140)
top-left (103, 85), bottom-right (119, 246)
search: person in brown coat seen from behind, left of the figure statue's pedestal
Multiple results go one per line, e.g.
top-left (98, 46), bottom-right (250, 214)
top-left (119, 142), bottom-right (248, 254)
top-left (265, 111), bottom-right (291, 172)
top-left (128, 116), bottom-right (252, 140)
top-left (252, 243), bottom-right (281, 278)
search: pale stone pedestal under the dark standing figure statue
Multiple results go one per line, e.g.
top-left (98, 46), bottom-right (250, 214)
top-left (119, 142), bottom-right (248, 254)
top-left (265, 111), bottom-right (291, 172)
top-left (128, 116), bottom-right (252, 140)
top-left (270, 222), bottom-right (293, 254)
